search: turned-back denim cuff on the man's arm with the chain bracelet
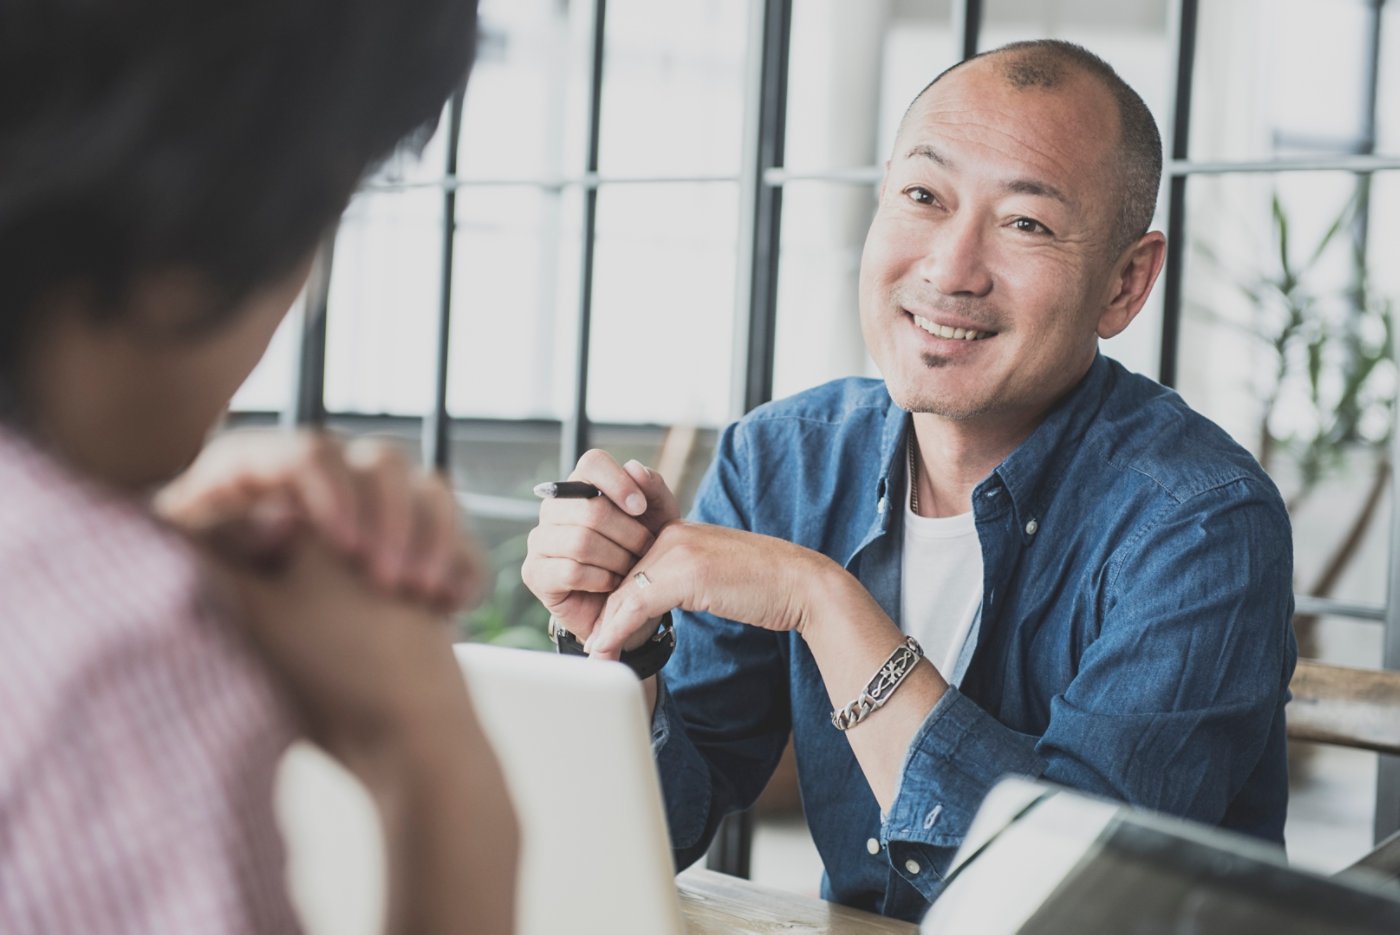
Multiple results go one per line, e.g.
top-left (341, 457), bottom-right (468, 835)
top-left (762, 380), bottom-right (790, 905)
top-left (881, 686), bottom-right (1046, 899)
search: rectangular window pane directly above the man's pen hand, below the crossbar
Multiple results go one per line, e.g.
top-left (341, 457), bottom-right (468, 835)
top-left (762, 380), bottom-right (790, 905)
top-left (588, 182), bottom-right (739, 426)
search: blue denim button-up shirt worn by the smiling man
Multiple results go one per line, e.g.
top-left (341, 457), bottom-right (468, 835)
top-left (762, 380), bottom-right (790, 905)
top-left (652, 356), bottom-right (1296, 920)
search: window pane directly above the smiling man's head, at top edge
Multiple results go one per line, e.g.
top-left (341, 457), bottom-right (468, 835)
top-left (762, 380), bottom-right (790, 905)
top-left (980, 0), bottom-right (1176, 149)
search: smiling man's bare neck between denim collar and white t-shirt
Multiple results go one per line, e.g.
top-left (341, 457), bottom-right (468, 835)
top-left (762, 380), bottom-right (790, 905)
top-left (914, 413), bottom-right (1035, 516)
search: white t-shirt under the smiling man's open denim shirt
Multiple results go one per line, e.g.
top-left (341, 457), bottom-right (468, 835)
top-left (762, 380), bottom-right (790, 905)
top-left (900, 497), bottom-right (981, 684)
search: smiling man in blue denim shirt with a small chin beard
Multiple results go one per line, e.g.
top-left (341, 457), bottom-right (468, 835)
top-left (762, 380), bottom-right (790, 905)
top-left (524, 41), bottom-right (1296, 918)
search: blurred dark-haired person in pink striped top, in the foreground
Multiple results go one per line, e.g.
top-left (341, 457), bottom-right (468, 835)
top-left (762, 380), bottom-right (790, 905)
top-left (0, 0), bottom-right (517, 934)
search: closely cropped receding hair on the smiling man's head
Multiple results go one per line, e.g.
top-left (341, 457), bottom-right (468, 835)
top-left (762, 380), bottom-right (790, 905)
top-left (906, 39), bottom-right (1162, 252)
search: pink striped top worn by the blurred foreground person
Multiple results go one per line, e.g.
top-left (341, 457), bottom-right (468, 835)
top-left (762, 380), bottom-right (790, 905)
top-left (0, 427), bottom-right (298, 935)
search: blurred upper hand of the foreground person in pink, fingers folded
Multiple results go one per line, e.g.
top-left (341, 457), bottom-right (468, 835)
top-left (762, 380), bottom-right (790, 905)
top-left (154, 431), bottom-right (486, 612)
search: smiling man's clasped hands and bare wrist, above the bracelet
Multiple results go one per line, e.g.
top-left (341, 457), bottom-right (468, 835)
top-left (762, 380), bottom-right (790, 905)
top-left (521, 449), bottom-right (844, 659)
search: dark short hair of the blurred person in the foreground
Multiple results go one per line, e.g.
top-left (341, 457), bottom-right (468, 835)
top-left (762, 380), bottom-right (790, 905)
top-left (0, 0), bottom-right (476, 382)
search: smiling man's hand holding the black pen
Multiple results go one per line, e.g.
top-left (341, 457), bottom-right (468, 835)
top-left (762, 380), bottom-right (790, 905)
top-left (521, 449), bottom-right (680, 642)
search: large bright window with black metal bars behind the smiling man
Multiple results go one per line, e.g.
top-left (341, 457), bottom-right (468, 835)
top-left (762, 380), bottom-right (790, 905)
top-left (226, 0), bottom-right (1400, 856)
